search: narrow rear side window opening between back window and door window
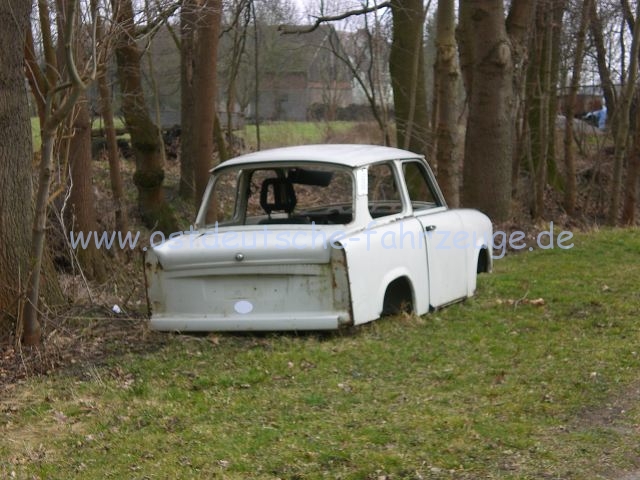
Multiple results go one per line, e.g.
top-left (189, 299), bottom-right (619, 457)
top-left (368, 163), bottom-right (402, 218)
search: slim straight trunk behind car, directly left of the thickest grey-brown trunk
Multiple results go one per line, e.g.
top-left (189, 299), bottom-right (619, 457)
top-left (435, 0), bottom-right (460, 207)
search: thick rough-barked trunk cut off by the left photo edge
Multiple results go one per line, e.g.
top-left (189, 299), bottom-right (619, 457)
top-left (0, 0), bottom-right (33, 338)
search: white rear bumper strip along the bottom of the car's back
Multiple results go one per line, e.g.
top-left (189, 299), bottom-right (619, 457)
top-left (151, 312), bottom-right (351, 332)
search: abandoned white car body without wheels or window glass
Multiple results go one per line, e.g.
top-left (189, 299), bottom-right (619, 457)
top-left (145, 145), bottom-right (492, 331)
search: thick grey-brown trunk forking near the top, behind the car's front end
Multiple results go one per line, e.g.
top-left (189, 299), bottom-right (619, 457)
top-left (459, 0), bottom-right (535, 222)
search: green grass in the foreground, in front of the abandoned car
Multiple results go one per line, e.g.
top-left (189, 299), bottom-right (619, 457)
top-left (0, 230), bottom-right (640, 479)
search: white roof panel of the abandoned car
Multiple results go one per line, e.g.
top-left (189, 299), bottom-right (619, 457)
top-left (211, 144), bottom-right (423, 172)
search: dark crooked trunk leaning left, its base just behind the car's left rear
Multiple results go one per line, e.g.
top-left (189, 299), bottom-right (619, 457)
top-left (112, 0), bottom-right (177, 233)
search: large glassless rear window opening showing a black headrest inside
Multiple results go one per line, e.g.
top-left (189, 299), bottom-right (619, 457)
top-left (201, 164), bottom-right (353, 226)
